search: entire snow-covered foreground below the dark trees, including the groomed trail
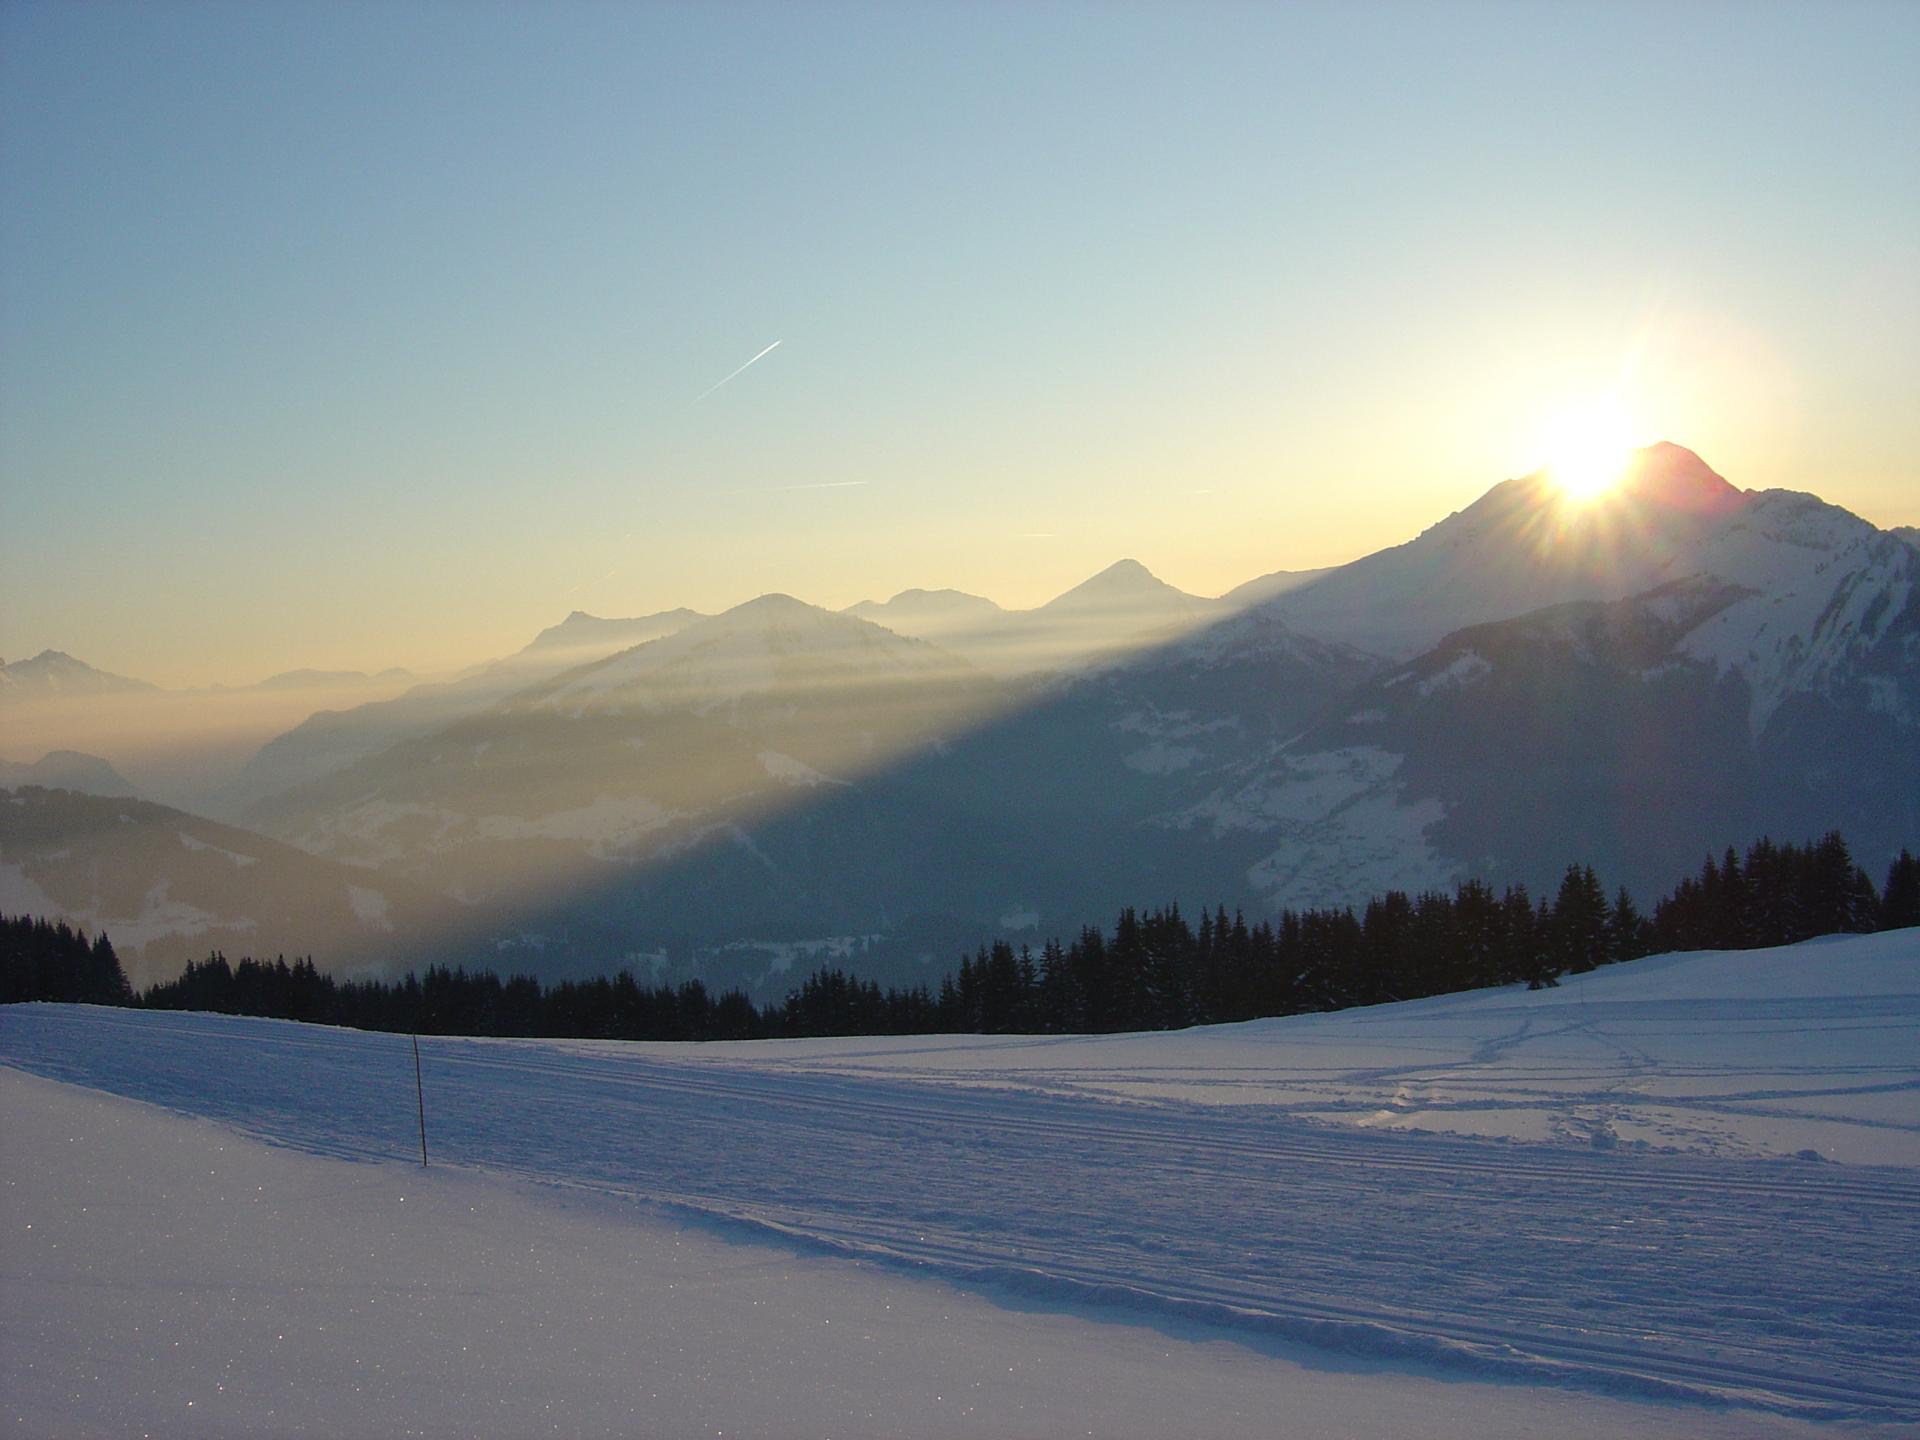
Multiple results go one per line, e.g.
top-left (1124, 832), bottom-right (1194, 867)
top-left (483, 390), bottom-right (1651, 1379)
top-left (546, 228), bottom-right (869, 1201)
top-left (0, 931), bottom-right (1920, 1436)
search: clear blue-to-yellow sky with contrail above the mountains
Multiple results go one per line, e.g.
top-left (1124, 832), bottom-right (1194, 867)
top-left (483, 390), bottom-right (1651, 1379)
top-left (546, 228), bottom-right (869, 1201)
top-left (0, 0), bottom-right (1920, 685)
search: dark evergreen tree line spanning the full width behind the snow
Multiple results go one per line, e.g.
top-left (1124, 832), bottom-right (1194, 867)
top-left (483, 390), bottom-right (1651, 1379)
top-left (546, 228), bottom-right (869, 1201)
top-left (0, 833), bottom-right (1920, 1041)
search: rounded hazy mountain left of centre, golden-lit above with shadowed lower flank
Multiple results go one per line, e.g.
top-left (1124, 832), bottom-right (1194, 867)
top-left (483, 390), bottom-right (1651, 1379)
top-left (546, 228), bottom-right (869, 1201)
top-left (243, 595), bottom-right (1000, 973)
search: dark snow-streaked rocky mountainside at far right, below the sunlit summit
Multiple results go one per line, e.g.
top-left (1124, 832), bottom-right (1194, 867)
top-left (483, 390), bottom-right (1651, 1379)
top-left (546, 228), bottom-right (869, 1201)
top-left (1164, 492), bottom-right (1920, 904)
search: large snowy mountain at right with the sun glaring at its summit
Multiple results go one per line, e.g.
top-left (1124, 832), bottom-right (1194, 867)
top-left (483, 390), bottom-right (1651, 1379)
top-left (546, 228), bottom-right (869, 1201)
top-left (1160, 445), bottom-right (1920, 904)
